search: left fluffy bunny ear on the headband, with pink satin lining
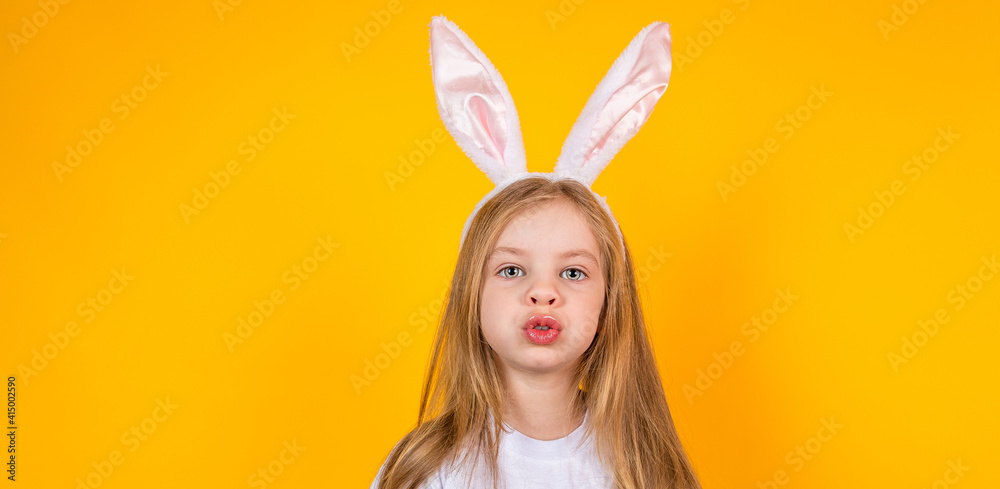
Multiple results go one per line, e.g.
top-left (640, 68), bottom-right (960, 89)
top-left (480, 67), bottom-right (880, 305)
top-left (430, 15), bottom-right (528, 185)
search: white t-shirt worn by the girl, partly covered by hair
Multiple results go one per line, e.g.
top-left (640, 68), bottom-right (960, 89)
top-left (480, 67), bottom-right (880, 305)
top-left (371, 415), bottom-right (612, 489)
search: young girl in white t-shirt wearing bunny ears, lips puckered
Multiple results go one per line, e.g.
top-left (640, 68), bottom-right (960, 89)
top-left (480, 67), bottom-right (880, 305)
top-left (372, 17), bottom-right (700, 489)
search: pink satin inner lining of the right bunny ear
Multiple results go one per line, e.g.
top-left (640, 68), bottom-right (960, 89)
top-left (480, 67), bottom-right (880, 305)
top-left (583, 24), bottom-right (671, 164)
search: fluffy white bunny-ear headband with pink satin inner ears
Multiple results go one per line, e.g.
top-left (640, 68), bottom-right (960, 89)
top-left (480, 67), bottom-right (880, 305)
top-left (430, 16), bottom-right (671, 250)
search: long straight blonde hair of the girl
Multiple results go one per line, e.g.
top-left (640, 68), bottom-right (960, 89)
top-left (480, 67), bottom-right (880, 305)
top-left (378, 177), bottom-right (701, 489)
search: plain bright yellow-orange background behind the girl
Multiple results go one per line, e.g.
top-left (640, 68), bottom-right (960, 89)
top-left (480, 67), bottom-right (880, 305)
top-left (0, 0), bottom-right (1000, 488)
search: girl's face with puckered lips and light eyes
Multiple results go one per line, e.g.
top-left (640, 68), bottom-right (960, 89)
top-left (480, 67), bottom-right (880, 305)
top-left (480, 199), bottom-right (604, 373)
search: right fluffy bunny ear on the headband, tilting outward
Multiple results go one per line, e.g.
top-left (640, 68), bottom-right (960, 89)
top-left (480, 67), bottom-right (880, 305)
top-left (555, 22), bottom-right (671, 185)
